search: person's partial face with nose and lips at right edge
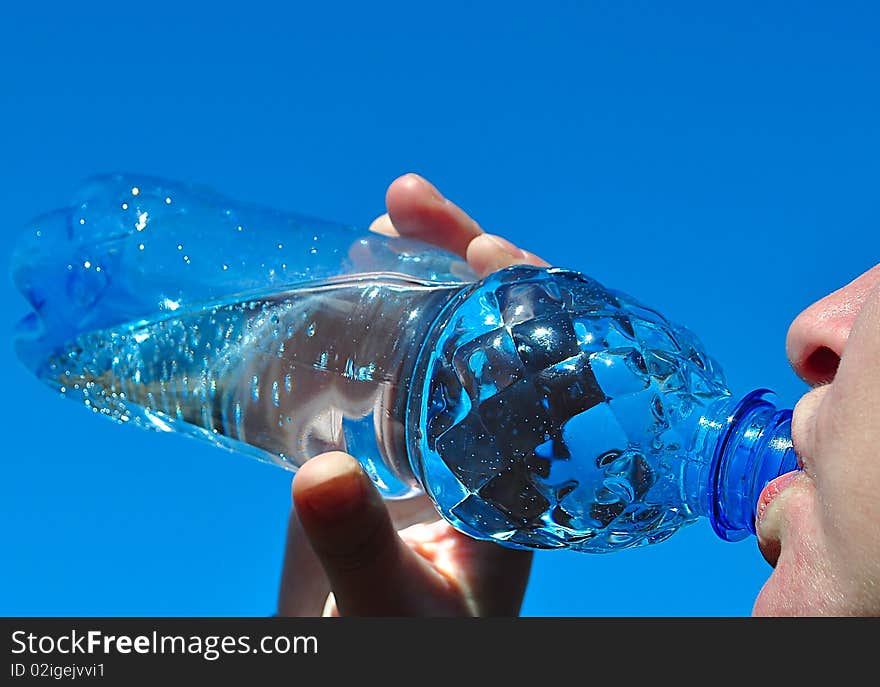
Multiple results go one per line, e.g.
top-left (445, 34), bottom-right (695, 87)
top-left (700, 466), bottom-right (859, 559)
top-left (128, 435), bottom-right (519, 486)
top-left (753, 265), bottom-right (880, 616)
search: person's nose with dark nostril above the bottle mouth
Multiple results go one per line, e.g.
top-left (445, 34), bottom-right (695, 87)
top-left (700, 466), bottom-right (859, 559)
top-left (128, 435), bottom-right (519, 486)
top-left (786, 265), bottom-right (880, 386)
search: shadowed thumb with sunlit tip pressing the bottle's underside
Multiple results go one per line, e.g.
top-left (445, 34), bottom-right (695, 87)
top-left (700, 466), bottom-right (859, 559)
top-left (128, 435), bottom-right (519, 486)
top-left (293, 452), bottom-right (461, 616)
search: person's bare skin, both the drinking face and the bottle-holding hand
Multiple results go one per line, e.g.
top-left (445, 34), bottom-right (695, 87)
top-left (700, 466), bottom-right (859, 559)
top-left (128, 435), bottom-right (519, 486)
top-left (278, 174), bottom-right (880, 616)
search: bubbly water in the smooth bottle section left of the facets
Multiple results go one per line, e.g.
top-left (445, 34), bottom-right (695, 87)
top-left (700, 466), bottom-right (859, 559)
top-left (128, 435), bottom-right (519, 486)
top-left (42, 274), bottom-right (458, 497)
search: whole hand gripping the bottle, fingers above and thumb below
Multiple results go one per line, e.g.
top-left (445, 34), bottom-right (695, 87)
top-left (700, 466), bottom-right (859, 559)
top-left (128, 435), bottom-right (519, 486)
top-left (278, 174), bottom-right (547, 616)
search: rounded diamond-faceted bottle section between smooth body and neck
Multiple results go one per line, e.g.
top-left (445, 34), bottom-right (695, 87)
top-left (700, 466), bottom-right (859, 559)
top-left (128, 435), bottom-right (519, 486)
top-left (408, 267), bottom-right (732, 552)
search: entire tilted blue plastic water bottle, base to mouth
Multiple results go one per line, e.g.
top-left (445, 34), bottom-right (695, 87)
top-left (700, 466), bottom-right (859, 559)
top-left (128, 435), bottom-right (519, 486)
top-left (13, 175), bottom-right (797, 552)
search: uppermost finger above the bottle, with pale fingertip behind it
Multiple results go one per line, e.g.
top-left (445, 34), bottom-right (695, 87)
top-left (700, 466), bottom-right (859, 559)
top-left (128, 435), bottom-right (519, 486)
top-left (382, 174), bottom-right (483, 257)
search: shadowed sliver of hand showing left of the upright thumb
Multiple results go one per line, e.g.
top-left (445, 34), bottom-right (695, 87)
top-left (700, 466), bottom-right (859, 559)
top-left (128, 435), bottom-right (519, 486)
top-left (278, 484), bottom-right (330, 617)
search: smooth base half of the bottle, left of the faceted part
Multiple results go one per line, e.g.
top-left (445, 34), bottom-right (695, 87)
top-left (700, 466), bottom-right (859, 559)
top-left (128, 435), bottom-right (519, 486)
top-left (12, 174), bottom-right (475, 496)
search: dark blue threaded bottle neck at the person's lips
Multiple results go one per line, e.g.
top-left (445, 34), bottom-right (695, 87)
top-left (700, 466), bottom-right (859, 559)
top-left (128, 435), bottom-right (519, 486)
top-left (697, 389), bottom-right (798, 541)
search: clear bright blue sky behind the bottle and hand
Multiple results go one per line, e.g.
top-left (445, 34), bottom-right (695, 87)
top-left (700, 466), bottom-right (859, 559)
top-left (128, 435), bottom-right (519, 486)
top-left (0, 1), bottom-right (880, 615)
